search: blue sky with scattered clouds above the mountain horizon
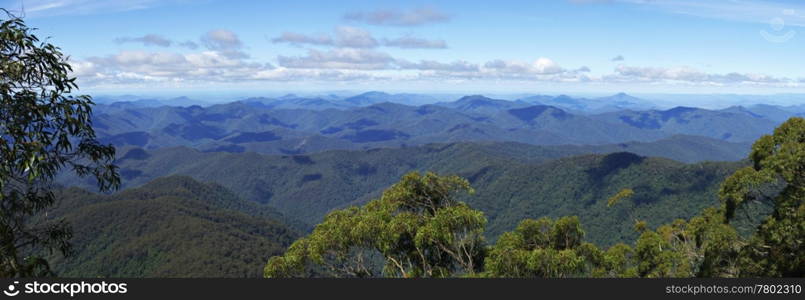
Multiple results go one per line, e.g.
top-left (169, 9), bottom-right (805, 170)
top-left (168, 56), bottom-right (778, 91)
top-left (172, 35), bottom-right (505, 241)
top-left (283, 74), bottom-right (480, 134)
top-left (0, 0), bottom-right (805, 94)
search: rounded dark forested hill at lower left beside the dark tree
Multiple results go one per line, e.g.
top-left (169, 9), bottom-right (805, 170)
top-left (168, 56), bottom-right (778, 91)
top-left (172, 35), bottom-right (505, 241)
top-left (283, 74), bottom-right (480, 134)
top-left (48, 176), bottom-right (299, 277)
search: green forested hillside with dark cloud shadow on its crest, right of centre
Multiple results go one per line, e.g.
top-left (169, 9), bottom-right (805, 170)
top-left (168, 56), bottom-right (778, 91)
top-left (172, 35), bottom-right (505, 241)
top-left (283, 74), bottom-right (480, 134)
top-left (472, 152), bottom-right (746, 246)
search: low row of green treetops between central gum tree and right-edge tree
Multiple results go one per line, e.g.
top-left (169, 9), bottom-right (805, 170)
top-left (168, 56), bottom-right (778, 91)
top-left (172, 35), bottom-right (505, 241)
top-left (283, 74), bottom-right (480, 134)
top-left (484, 208), bottom-right (738, 278)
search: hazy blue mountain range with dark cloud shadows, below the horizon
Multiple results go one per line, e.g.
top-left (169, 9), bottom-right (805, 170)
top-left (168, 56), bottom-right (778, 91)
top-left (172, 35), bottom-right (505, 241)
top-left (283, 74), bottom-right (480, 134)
top-left (86, 92), bottom-right (780, 154)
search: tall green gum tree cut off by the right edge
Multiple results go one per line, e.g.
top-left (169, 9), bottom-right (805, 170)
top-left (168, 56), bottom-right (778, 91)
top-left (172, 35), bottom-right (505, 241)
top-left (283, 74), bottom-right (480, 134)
top-left (720, 118), bottom-right (805, 277)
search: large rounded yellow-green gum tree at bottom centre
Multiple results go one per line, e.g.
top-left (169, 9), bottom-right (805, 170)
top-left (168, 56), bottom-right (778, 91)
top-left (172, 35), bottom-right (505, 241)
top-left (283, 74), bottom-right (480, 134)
top-left (264, 172), bottom-right (486, 277)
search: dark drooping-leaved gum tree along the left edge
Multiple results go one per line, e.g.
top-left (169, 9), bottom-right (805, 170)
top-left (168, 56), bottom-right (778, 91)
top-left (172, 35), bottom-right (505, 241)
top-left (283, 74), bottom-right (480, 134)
top-left (0, 12), bottom-right (120, 277)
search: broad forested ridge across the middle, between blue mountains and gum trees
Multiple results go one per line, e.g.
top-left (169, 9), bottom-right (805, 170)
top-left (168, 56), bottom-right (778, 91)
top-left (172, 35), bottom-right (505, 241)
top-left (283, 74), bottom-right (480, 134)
top-left (59, 143), bottom-right (742, 244)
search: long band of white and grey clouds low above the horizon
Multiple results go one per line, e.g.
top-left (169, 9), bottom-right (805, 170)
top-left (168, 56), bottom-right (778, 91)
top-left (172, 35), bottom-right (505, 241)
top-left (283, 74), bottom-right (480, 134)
top-left (71, 26), bottom-right (805, 87)
